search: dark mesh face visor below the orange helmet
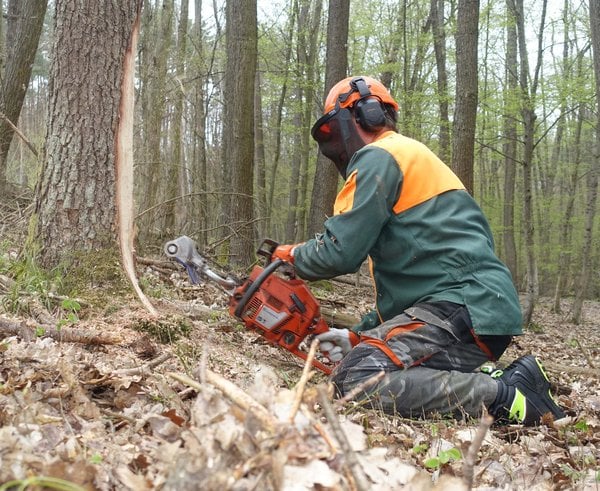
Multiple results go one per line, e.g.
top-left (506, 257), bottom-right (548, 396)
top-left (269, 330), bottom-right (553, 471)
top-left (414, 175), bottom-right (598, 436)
top-left (310, 108), bottom-right (356, 179)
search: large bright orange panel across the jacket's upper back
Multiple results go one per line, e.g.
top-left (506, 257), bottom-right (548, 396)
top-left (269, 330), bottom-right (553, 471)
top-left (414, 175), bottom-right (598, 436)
top-left (371, 133), bottom-right (465, 214)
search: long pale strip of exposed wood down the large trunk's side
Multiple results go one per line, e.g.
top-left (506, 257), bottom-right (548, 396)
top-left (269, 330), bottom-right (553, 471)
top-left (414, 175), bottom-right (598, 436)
top-left (115, 2), bottom-right (158, 317)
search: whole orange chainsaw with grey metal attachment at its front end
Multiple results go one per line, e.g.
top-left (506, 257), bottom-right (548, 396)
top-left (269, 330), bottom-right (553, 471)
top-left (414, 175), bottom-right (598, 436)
top-left (164, 235), bottom-right (331, 374)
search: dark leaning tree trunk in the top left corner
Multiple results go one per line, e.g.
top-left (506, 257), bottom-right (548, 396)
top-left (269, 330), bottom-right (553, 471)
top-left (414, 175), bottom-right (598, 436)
top-left (0, 0), bottom-right (48, 194)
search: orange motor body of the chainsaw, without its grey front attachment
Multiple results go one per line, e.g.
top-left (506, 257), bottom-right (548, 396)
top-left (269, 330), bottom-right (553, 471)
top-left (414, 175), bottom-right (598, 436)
top-left (229, 263), bottom-right (331, 374)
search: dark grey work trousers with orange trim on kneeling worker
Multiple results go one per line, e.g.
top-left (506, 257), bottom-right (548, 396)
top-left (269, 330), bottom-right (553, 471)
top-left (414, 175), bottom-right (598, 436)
top-left (332, 303), bottom-right (509, 418)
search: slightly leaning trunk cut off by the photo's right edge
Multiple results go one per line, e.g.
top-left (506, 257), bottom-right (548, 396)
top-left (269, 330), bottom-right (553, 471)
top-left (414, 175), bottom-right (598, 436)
top-left (573, 0), bottom-right (600, 324)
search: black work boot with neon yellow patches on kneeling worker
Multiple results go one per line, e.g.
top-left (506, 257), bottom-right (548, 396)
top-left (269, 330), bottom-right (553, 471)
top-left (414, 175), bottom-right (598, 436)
top-left (489, 355), bottom-right (565, 426)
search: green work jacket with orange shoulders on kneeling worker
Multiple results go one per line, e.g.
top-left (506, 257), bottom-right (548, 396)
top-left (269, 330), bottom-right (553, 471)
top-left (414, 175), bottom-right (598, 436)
top-left (294, 131), bottom-right (522, 335)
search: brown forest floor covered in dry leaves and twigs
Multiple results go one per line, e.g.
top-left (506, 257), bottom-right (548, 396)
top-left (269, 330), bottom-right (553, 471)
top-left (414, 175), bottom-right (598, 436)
top-left (0, 198), bottom-right (600, 491)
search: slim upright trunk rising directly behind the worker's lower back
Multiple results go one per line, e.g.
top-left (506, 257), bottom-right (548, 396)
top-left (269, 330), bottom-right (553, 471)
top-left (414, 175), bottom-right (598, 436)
top-left (502, 0), bottom-right (519, 284)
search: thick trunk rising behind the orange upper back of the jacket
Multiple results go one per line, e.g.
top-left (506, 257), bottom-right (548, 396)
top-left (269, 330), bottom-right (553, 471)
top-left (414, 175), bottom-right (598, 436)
top-left (452, 0), bottom-right (479, 194)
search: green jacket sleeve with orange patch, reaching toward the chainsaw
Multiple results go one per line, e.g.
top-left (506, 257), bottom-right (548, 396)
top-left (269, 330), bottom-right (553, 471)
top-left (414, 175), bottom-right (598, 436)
top-left (294, 146), bottom-right (402, 280)
